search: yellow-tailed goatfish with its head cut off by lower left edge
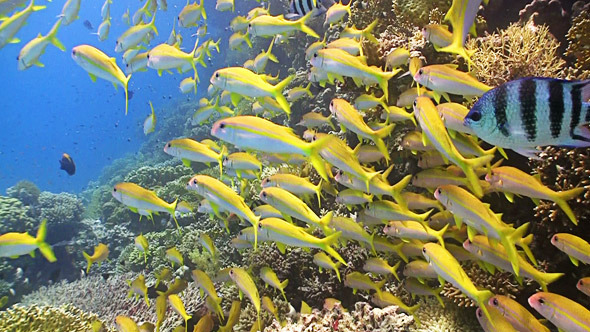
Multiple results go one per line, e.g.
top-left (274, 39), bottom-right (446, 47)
top-left (0, 220), bottom-right (57, 263)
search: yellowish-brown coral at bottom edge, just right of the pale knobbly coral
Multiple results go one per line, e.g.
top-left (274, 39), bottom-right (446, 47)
top-left (409, 297), bottom-right (481, 332)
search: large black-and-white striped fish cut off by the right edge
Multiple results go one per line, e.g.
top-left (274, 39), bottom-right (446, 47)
top-left (464, 77), bottom-right (590, 157)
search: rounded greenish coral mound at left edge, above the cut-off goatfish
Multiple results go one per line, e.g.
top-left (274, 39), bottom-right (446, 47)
top-left (0, 196), bottom-right (38, 234)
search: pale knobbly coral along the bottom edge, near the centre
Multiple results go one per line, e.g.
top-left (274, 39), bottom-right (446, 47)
top-left (264, 302), bottom-right (413, 332)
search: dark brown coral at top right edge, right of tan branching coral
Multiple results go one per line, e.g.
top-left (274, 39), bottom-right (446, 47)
top-left (566, 10), bottom-right (590, 70)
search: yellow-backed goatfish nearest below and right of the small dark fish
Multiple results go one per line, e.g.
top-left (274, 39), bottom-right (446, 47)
top-left (111, 182), bottom-right (181, 233)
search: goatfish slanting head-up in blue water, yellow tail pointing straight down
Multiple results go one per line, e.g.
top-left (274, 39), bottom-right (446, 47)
top-left (72, 45), bottom-right (131, 114)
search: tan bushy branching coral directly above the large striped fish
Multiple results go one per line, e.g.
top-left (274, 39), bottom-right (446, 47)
top-left (467, 23), bottom-right (565, 86)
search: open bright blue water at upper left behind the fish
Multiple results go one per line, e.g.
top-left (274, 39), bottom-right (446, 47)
top-left (0, 0), bottom-right (242, 193)
